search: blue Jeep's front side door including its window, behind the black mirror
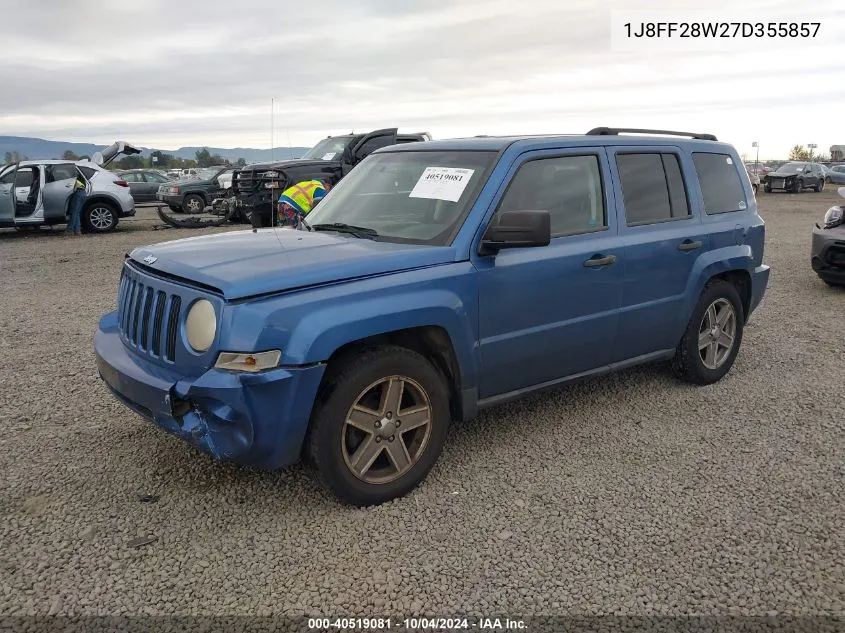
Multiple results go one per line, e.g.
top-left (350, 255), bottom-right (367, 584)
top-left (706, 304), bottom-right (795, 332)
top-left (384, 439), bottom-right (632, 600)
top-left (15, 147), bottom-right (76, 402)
top-left (473, 148), bottom-right (624, 399)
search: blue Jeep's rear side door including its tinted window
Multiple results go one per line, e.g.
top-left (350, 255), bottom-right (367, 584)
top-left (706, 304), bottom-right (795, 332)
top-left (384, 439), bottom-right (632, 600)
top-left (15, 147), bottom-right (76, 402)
top-left (608, 145), bottom-right (712, 362)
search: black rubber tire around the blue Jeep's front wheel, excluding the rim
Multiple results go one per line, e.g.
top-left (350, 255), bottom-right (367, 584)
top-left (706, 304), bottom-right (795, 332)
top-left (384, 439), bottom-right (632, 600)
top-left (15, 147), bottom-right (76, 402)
top-left (307, 346), bottom-right (451, 507)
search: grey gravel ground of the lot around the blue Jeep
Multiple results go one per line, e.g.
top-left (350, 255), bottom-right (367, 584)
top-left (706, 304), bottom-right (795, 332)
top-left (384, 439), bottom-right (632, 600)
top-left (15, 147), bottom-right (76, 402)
top-left (0, 190), bottom-right (845, 616)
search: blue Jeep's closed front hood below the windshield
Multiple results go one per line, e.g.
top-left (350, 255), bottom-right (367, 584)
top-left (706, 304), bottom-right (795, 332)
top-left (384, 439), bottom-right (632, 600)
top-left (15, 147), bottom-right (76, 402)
top-left (129, 229), bottom-right (454, 300)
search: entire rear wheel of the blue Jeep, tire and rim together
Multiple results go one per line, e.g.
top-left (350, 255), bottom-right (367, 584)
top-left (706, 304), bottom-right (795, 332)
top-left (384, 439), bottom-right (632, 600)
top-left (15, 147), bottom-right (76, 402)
top-left (672, 279), bottom-right (745, 385)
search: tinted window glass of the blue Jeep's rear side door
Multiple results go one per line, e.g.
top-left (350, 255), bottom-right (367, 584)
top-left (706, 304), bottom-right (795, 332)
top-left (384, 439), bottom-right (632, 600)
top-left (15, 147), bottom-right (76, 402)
top-left (616, 152), bottom-right (690, 226)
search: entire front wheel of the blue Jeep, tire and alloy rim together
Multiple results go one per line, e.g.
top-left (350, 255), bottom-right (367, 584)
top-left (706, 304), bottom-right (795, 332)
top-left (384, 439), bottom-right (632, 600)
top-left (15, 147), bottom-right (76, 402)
top-left (308, 346), bottom-right (451, 506)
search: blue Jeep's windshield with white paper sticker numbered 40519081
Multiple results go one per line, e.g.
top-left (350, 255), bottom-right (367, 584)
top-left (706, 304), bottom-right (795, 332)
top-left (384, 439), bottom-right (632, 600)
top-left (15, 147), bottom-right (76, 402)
top-left (307, 151), bottom-right (497, 246)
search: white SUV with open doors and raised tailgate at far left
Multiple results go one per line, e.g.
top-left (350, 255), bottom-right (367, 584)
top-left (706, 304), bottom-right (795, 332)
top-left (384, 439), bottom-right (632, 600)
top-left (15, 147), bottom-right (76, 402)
top-left (0, 142), bottom-right (141, 233)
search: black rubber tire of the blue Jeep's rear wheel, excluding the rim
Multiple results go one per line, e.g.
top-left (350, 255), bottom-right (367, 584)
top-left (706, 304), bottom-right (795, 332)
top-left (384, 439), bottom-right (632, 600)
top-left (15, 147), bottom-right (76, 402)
top-left (672, 279), bottom-right (745, 385)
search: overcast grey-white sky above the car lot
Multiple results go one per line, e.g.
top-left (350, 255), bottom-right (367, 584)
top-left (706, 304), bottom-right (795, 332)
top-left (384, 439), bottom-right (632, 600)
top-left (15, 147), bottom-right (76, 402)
top-left (0, 0), bottom-right (845, 158)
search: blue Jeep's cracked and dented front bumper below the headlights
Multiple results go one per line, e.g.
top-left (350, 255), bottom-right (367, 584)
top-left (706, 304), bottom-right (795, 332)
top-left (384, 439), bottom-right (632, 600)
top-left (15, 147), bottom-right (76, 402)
top-left (94, 312), bottom-right (325, 469)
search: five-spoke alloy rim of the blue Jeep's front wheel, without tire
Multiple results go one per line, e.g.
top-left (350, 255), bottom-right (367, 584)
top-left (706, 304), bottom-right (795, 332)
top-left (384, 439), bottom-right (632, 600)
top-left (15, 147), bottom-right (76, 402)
top-left (341, 376), bottom-right (432, 484)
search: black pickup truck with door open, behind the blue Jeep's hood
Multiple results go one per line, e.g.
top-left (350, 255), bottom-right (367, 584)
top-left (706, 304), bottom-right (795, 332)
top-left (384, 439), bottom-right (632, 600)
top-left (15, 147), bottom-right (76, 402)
top-left (232, 128), bottom-right (431, 227)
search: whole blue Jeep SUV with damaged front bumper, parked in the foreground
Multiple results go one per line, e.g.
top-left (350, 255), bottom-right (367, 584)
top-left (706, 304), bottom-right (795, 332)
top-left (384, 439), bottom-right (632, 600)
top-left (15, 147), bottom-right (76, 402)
top-left (94, 128), bottom-right (769, 505)
